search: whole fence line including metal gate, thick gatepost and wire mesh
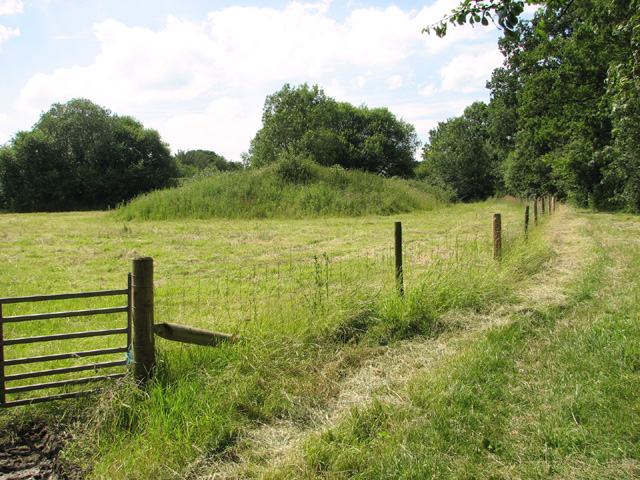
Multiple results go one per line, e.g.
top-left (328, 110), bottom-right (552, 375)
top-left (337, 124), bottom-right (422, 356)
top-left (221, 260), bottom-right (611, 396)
top-left (0, 199), bottom-right (555, 407)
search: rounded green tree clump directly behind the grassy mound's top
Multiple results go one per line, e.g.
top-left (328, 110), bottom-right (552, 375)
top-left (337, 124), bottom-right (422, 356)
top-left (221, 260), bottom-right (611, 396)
top-left (249, 84), bottom-right (418, 177)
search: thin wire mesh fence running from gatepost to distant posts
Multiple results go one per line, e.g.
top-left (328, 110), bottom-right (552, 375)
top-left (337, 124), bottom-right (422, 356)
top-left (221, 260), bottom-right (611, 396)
top-left (156, 204), bottom-right (540, 348)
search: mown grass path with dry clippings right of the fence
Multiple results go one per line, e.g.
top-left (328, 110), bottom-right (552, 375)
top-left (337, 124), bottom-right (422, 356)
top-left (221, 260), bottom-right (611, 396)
top-left (206, 209), bottom-right (640, 479)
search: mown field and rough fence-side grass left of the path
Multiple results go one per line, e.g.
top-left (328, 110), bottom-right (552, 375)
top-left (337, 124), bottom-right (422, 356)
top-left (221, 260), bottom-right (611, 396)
top-left (0, 197), bottom-right (549, 478)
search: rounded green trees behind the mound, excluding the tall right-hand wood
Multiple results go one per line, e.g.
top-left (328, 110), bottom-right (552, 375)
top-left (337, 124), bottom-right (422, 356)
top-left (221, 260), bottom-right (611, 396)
top-left (0, 84), bottom-right (419, 212)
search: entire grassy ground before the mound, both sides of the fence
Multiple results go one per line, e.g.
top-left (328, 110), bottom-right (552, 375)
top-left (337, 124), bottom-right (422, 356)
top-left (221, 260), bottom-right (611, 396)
top-left (0, 201), bottom-right (640, 478)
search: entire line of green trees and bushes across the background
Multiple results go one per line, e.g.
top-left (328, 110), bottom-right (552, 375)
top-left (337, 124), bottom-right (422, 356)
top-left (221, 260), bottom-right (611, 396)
top-left (0, 0), bottom-right (640, 212)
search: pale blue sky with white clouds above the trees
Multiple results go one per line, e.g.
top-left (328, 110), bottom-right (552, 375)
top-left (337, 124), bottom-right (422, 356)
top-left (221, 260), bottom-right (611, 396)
top-left (0, 0), bottom-right (510, 161)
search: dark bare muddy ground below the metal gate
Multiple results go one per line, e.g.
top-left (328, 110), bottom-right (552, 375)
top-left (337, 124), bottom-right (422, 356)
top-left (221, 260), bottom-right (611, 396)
top-left (0, 424), bottom-right (84, 480)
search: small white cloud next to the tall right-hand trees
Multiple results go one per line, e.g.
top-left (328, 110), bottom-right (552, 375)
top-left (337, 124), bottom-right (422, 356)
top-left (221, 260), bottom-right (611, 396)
top-left (439, 48), bottom-right (504, 93)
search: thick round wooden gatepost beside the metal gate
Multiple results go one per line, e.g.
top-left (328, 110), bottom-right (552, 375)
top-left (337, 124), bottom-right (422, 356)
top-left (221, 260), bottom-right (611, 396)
top-left (131, 257), bottom-right (156, 384)
